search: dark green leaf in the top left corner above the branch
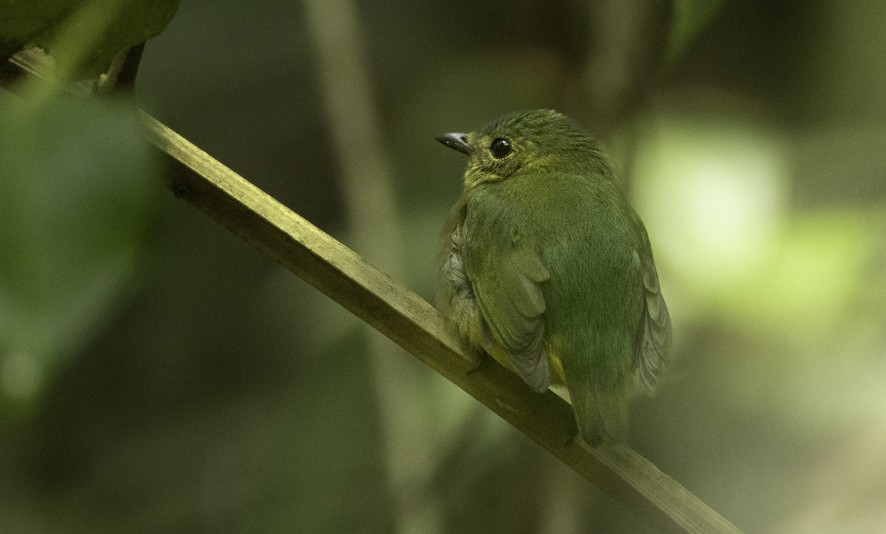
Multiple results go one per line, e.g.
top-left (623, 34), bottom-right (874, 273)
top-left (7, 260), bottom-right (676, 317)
top-left (0, 0), bottom-right (179, 79)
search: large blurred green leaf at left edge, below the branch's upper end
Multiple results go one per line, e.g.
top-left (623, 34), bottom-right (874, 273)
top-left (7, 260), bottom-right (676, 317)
top-left (0, 94), bottom-right (161, 406)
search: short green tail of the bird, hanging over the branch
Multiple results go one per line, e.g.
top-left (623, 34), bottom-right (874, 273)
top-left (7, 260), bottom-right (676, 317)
top-left (569, 385), bottom-right (625, 446)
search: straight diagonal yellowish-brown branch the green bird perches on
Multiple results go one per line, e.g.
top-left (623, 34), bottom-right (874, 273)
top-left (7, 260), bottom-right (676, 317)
top-left (143, 114), bottom-right (739, 533)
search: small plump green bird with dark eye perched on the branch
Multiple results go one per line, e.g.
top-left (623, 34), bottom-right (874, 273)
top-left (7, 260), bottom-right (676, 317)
top-left (437, 110), bottom-right (671, 445)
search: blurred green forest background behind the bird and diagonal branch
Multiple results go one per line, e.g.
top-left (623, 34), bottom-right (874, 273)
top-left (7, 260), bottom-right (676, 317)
top-left (0, 0), bottom-right (886, 533)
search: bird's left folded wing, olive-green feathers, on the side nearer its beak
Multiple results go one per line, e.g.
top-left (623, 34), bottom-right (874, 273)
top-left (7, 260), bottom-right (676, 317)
top-left (471, 249), bottom-right (551, 392)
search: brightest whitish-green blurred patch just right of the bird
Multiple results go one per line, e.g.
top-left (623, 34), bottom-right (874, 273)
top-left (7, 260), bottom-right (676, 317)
top-left (634, 112), bottom-right (789, 298)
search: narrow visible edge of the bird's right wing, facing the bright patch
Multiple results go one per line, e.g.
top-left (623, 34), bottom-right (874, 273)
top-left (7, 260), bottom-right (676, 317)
top-left (637, 237), bottom-right (671, 391)
